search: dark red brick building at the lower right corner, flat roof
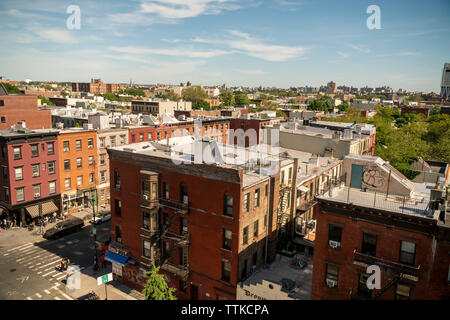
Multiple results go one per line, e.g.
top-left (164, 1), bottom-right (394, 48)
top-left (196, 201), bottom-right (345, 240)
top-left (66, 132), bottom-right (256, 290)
top-left (311, 187), bottom-right (450, 300)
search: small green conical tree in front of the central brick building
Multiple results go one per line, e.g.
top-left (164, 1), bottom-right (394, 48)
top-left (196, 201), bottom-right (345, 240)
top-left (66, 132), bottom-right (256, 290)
top-left (142, 263), bottom-right (177, 300)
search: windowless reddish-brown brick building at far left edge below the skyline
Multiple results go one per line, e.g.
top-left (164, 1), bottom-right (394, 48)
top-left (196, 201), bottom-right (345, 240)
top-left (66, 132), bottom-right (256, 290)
top-left (0, 85), bottom-right (52, 130)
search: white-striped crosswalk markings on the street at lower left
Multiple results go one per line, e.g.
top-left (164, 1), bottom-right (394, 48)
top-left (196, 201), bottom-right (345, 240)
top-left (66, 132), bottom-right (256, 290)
top-left (0, 241), bottom-right (84, 300)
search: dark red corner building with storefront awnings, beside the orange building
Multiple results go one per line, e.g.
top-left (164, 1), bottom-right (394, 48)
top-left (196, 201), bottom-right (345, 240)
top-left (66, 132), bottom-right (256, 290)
top-left (0, 129), bottom-right (61, 225)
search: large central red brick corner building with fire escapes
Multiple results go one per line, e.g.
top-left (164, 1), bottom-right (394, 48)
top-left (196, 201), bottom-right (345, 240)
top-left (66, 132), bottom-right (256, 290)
top-left (108, 139), bottom-right (279, 300)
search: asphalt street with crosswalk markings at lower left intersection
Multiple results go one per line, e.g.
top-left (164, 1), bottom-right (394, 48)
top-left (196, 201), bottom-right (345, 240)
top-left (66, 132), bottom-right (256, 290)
top-left (0, 221), bottom-right (110, 300)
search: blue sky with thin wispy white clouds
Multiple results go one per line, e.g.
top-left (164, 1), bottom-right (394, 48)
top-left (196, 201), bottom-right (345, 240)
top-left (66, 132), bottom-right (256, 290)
top-left (0, 0), bottom-right (450, 92)
